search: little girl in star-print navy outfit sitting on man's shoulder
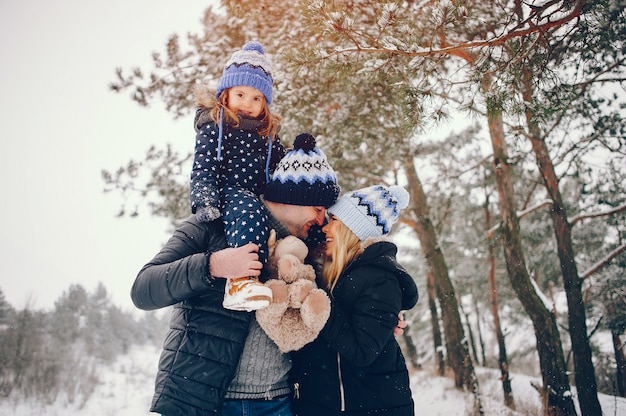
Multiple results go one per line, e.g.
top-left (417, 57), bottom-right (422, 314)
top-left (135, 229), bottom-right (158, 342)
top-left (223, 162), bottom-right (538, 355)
top-left (190, 42), bottom-right (285, 311)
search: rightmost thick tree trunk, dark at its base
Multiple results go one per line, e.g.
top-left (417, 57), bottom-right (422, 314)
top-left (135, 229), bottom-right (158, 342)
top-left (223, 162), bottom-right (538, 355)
top-left (522, 68), bottom-right (602, 416)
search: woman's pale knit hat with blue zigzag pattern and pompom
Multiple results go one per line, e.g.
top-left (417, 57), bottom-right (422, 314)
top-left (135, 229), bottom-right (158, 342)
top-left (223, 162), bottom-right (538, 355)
top-left (328, 185), bottom-right (409, 241)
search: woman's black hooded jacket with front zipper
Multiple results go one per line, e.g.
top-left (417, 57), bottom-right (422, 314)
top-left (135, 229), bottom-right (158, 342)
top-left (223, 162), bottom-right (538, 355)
top-left (294, 241), bottom-right (418, 416)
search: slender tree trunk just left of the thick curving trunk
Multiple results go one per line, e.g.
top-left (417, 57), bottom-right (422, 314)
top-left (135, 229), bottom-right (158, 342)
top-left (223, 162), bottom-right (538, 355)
top-left (485, 194), bottom-right (515, 410)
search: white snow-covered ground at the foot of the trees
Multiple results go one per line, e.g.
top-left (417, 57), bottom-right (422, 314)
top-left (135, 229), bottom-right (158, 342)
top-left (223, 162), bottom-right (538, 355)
top-left (0, 347), bottom-right (626, 416)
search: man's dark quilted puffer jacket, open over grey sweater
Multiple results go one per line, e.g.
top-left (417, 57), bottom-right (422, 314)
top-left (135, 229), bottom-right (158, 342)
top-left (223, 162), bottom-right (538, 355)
top-left (131, 216), bottom-right (253, 416)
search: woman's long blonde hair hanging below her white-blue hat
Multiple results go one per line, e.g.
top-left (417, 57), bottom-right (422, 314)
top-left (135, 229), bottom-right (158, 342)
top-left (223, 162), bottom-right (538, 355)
top-left (322, 220), bottom-right (363, 292)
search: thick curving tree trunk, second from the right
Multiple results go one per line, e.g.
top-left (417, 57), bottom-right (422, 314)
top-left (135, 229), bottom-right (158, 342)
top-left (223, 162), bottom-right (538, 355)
top-left (482, 76), bottom-right (576, 416)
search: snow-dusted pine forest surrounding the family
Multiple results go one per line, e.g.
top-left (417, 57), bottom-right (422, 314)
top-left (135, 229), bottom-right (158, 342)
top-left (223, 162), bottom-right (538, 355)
top-left (0, 0), bottom-right (626, 416)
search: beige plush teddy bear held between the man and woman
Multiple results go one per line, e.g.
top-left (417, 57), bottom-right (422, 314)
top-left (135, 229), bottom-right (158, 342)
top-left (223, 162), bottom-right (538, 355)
top-left (256, 230), bottom-right (330, 353)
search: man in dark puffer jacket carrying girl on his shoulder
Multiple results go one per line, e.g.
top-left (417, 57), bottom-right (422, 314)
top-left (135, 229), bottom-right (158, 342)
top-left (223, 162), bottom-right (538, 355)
top-left (131, 135), bottom-right (339, 416)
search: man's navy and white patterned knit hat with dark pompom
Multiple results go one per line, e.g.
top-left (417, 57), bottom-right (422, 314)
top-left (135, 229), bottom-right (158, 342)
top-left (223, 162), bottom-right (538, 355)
top-left (265, 133), bottom-right (339, 207)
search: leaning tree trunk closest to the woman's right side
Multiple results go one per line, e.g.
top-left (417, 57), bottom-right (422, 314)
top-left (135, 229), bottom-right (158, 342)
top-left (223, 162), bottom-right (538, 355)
top-left (403, 157), bottom-right (478, 394)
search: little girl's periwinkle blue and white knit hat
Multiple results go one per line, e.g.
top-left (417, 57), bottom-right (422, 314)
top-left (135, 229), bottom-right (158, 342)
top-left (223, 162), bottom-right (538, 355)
top-left (215, 41), bottom-right (274, 105)
